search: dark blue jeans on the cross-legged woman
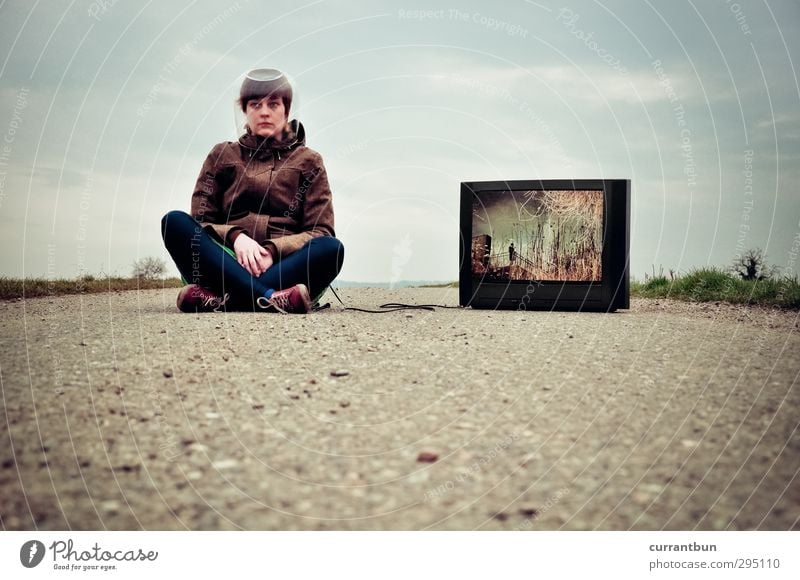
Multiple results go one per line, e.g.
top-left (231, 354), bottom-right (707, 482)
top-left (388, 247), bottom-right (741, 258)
top-left (161, 210), bottom-right (344, 310)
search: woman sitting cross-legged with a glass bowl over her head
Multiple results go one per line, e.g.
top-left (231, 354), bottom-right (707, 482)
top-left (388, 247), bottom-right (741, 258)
top-left (161, 69), bottom-right (344, 313)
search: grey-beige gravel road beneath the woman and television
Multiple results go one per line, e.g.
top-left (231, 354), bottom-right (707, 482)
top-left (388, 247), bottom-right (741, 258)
top-left (0, 289), bottom-right (800, 530)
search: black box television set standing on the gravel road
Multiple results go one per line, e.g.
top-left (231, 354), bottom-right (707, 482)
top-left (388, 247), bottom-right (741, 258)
top-left (459, 179), bottom-right (631, 312)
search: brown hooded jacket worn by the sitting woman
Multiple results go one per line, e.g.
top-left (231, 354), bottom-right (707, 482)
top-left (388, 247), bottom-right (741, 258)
top-left (192, 121), bottom-right (335, 261)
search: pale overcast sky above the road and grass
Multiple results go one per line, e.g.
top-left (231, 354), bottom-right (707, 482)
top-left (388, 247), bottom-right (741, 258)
top-left (0, 0), bottom-right (800, 281)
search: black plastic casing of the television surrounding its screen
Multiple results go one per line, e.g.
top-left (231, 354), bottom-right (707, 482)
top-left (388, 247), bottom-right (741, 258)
top-left (459, 179), bottom-right (631, 312)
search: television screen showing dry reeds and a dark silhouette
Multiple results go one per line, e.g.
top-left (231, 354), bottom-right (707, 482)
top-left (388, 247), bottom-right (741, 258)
top-left (472, 190), bottom-right (603, 282)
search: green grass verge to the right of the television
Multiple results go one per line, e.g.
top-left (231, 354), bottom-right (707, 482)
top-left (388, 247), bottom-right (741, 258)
top-left (631, 268), bottom-right (800, 309)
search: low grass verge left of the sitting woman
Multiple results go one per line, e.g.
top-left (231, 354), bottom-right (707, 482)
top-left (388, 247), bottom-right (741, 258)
top-left (0, 276), bottom-right (183, 300)
